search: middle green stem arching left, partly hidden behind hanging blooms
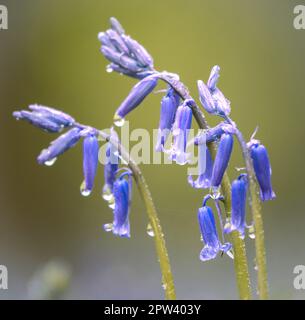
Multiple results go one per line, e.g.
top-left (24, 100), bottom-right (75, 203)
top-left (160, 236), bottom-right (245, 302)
top-left (160, 72), bottom-right (252, 300)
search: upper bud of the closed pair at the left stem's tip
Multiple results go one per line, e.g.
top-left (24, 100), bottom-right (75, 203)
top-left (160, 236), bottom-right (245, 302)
top-left (29, 104), bottom-right (75, 127)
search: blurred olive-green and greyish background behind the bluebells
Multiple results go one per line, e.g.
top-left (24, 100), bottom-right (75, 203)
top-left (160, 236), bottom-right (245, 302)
top-left (0, 0), bottom-right (305, 299)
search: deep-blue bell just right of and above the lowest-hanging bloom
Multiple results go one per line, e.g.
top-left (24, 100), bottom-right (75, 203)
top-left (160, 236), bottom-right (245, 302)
top-left (224, 174), bottom-right (248, 238)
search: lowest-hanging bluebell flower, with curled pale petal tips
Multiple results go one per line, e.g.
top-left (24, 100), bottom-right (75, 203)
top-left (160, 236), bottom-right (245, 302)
top-left (198, 204), bottom-right (232, 261)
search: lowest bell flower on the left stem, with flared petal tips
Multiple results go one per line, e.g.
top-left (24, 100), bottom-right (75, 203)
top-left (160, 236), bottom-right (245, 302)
top-left (104, 171), bottom-right (132, 238)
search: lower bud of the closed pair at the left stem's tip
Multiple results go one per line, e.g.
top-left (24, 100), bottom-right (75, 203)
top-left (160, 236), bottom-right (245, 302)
top-left (13, 110), bottom-right (63, 132)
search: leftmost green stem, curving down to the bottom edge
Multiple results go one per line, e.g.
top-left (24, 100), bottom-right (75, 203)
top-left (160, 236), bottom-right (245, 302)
top-left (100, 131), bottom-right (176, 300)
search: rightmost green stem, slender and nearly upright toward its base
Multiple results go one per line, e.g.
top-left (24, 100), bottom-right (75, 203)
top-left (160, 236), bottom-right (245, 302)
top-left (226, 117), bottom-right (268, 300)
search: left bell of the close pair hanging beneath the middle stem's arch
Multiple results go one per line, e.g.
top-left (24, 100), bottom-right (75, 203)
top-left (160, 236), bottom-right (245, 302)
top-left (156, 88), bottom-right (180, 151)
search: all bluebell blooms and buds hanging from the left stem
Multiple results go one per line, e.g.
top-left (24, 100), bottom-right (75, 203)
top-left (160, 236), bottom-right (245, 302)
top-left (13, 105), bottom-right (132, 237)
